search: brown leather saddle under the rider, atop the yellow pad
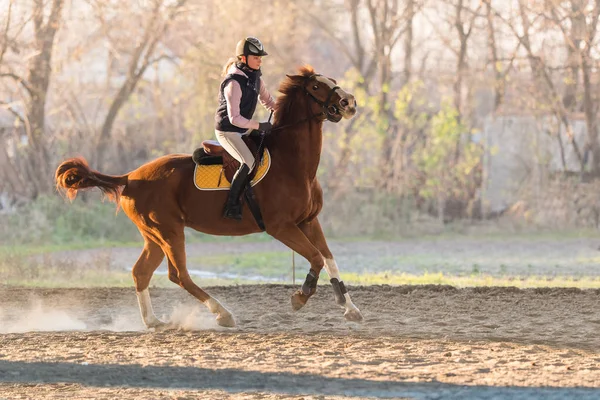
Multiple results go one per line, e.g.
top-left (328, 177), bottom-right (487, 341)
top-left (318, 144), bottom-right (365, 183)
top-left (192, 134), bottom-right (264, 182)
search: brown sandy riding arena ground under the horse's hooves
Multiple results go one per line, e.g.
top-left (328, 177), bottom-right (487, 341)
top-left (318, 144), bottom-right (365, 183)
top-left (0, 285), bottom-right (600, 399)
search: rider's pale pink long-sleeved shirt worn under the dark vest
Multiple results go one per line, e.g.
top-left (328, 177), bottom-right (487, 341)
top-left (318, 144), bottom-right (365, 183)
top-left (223, 64), bottom-right (275, 129)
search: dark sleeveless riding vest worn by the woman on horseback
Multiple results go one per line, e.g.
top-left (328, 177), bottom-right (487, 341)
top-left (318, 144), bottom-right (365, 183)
top-left (215, 67), bottom-right (260, 133)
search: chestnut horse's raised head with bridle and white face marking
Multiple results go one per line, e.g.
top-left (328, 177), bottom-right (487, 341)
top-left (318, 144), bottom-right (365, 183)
top-left (288, 67), bottom-right (356, 122)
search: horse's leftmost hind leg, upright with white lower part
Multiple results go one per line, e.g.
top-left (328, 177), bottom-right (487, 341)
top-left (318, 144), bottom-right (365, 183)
top-left (132, 234), bottom-right (165, 328)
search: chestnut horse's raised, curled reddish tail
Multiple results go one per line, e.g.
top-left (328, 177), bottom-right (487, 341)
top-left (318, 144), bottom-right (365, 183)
top-left (55, 157), bottom-right (128, 204)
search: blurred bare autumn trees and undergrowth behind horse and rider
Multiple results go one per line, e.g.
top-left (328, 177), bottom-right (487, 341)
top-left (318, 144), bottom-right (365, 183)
top-left (0, 0), bottom-right (600, 284)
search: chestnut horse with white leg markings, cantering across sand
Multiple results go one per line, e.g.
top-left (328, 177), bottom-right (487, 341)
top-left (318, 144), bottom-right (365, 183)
top-left (56, 66), bottom-right (362, 328)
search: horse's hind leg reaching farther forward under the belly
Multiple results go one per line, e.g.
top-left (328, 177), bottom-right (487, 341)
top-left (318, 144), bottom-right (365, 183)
top-left (162, 228), bottom-right (235, 327)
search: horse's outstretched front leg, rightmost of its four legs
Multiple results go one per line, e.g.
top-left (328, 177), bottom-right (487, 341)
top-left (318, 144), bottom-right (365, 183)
top-left (299, 218), bottom-right (363, 322)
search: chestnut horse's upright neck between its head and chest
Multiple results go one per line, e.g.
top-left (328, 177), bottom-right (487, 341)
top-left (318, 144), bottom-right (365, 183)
top-left (269, 105), bottom-right (323, 180)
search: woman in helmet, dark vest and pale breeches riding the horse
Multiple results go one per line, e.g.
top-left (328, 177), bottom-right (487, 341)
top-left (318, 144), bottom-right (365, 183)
top-left (215, 37), bottom-right (275, 220)
